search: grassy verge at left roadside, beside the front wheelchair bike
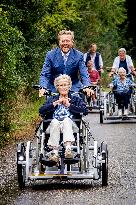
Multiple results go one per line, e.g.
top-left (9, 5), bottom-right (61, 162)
top-left (0, 97), bottom-right (45, 148)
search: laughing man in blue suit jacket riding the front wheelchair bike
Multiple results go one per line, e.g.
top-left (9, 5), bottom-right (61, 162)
top-left (39, 30), bottom-right (93, 97)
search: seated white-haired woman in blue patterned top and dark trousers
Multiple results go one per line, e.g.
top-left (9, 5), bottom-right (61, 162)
top-left (112, 67), bottom-right (133, 116)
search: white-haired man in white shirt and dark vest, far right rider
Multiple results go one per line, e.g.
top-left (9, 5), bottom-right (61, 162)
top-left (109, 48), bottom-right (136, 77)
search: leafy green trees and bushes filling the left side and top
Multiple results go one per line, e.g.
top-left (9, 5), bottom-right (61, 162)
top-left (0, 0), bottom-right (132, 144)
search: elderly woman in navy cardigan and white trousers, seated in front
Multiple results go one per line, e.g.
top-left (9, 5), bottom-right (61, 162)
top-left (39, 74), bottom-right (87, 161)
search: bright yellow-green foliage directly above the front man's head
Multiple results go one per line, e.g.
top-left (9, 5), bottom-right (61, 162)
top-left (38, 0), bottom-right (81, 32)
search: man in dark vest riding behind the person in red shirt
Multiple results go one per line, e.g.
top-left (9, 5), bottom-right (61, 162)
top-left (84, 43), bottom-right (104, 75)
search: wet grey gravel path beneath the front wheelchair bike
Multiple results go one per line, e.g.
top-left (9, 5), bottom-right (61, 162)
top-left (0, 114), bottom-right (136, 205)
